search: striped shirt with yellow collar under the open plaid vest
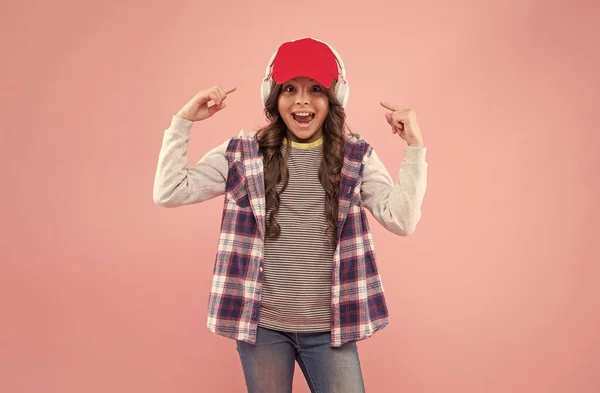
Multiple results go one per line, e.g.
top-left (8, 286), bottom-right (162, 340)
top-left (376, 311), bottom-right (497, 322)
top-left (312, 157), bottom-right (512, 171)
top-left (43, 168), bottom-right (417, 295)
top-left (259, 139), bottom-right (334, 332)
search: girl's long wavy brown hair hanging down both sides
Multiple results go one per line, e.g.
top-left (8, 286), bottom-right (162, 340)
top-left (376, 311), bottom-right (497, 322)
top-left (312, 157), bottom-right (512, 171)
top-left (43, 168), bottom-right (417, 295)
top-left (256, 81), bottom-right (351, 248)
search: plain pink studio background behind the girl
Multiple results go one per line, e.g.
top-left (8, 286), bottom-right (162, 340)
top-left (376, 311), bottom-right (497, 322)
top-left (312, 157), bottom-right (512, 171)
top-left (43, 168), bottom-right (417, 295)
top-left (0, 0), bottom-right (600, 393)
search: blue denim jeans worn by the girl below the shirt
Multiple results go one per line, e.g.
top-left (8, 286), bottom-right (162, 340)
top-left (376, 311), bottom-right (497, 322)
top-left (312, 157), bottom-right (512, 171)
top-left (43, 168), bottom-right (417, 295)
top-left (237, 327), bottom-right (365, 393)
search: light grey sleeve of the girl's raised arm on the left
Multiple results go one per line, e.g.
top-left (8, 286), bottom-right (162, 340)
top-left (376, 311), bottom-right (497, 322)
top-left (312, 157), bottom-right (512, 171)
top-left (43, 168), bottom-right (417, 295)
top-left (153, 116), bottom-right (229, 207)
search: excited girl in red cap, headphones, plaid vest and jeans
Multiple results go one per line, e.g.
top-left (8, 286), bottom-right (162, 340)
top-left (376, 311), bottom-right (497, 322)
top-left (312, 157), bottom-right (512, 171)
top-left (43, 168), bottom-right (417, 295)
top-left (154, 38), bottom-right (427, 393)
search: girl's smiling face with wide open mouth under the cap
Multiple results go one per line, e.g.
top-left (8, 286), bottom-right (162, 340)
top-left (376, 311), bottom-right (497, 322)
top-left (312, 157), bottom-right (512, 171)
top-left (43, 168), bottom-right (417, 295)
top-left (278, 77), bottom-right (329, 143)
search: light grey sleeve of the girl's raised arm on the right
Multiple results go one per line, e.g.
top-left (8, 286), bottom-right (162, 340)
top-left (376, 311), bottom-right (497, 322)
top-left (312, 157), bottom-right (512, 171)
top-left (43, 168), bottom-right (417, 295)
top-left (361, 146), bottom-right (428, 236)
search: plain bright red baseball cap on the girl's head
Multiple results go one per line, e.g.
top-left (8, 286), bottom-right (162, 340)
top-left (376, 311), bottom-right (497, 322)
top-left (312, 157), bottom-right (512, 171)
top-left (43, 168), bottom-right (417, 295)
top-left (272, 38), bottom-right (338, 88)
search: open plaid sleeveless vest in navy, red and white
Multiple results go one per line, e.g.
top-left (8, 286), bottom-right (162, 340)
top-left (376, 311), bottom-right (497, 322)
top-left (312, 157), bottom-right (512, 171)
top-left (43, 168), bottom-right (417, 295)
top-left (207, 134), bottom-right (388, 347)
